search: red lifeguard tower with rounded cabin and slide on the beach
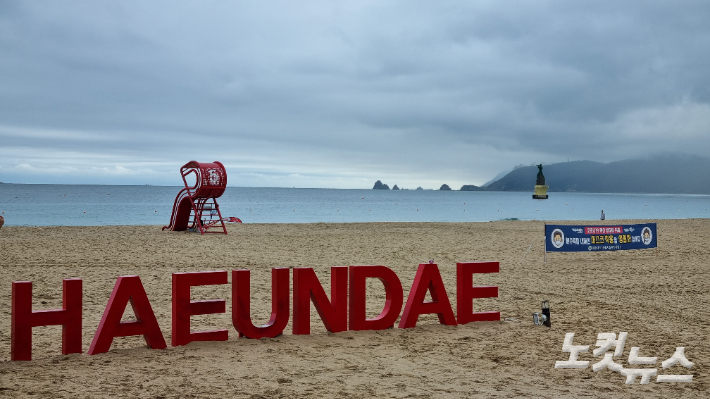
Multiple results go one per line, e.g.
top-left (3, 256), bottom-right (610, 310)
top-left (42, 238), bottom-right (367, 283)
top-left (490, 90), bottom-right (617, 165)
top-left (163, 161), bottom-right (227, 234)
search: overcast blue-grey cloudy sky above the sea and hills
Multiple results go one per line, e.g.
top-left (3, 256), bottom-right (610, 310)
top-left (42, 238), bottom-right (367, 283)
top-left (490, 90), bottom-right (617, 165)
top-left (0, 0), bottom-right (710, 189)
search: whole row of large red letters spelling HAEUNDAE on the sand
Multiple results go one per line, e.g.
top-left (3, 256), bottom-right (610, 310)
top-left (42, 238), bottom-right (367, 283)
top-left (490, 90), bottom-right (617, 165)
top-left (11, 262), bottom-right (500, 360)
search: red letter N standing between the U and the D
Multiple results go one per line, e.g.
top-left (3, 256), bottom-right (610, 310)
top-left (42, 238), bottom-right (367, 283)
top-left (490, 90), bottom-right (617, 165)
top-left (293, 266), bottom-right (348, 335)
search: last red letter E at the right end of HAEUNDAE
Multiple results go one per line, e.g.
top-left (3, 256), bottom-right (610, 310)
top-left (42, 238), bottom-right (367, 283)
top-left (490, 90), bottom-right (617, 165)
top-left (456, 262), bottom-right (500, 324)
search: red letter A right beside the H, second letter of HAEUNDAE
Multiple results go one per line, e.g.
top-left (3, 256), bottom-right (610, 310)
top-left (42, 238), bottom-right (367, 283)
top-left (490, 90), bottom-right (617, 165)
top-left (88, 276), bottom-right (167, 355)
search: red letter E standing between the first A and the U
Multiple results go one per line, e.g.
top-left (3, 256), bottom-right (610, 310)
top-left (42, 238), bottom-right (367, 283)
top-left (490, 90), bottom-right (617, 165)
top-left (170, 270), bottom-right (229, 346)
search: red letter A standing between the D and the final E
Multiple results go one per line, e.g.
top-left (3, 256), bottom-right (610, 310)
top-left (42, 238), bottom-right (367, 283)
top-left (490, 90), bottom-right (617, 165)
top-left (399, 263), bottom-right (456, 328)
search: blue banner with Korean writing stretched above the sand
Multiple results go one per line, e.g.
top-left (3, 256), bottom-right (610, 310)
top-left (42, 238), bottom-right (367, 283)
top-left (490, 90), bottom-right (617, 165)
top-left (545, 223), bottom-right (657, 252)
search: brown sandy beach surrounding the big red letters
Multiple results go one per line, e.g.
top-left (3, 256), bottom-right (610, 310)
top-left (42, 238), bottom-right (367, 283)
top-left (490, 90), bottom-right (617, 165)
top-left (0, 219), bottom-right (710, 398)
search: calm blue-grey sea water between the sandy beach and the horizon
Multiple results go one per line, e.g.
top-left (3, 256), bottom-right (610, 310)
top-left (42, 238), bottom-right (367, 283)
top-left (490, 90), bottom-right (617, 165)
top-left (0, 184), bottom-right (710, 226)
